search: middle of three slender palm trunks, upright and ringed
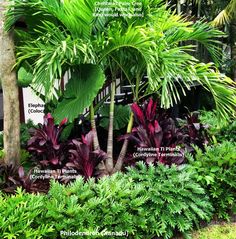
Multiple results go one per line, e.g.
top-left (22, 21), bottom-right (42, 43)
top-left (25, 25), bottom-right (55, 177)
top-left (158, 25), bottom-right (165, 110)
top-left (106, 79), bottom-right (116, 173)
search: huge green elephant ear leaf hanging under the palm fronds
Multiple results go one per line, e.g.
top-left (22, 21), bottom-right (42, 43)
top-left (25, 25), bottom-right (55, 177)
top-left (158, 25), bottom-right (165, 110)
top-left (54, 64), bottom-right (105, 122)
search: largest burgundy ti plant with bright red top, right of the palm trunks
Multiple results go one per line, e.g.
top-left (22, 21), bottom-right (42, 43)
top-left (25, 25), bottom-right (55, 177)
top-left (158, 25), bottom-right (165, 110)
top-left (121, 98), bottom-right (184, 164)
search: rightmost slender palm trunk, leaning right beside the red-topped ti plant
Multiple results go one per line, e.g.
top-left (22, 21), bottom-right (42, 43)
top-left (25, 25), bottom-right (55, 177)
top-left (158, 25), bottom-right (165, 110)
top-left (112, 113), bottom-right (134, 173)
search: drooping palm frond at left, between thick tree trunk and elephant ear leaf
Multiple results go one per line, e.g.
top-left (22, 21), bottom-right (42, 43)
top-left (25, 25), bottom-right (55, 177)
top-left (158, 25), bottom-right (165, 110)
top-left (17, 19), bottom-right (96, 100)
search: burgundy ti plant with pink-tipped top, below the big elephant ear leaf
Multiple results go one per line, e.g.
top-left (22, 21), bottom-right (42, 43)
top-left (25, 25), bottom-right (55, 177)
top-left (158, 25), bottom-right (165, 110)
top-left (28, 113), bottom-right (67, 167)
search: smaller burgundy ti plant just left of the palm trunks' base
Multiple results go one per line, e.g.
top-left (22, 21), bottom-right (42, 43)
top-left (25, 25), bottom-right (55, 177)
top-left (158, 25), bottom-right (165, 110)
top-left (66, 131), bottom-right (107, 179)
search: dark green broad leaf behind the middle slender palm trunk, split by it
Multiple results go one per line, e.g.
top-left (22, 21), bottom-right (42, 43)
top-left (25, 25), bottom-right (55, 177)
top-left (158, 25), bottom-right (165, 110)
top-left (99, 105), bottom-right (131, 130)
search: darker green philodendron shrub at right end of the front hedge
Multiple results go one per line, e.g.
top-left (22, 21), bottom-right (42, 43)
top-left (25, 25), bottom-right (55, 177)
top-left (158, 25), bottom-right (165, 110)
top-left (127, 163), bottom-right (213, 238)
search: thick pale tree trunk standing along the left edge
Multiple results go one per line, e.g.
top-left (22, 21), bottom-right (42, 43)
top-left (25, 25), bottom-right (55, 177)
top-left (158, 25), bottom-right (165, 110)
top-left (0, 0), bottom-right (20, 164)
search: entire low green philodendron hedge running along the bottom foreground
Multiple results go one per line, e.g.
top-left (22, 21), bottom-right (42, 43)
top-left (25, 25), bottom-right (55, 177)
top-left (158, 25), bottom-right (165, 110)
top-left (0, 163), bottom-right (212, 239)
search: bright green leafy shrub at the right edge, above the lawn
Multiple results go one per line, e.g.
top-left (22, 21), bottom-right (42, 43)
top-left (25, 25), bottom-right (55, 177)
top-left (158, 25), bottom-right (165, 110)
top-left (188, 141), bottom-right (236, 219)
